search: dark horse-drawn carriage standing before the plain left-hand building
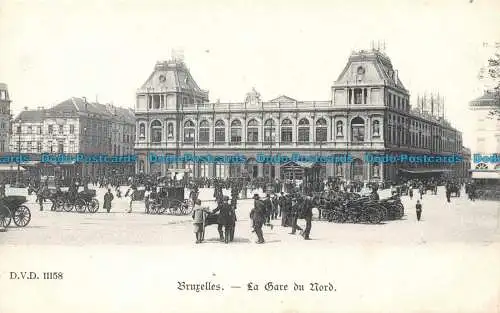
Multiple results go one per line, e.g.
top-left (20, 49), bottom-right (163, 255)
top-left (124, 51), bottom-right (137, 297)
top-left (48, 189), bottom-right (99, 213)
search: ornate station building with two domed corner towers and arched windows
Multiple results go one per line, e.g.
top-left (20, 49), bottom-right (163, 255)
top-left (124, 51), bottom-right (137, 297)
top-left (135, 50), bottom-right (466, 181)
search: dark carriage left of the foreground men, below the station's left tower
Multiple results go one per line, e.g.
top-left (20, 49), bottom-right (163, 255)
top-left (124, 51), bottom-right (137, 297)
top-left (145, 186), bottom-right (193, 215)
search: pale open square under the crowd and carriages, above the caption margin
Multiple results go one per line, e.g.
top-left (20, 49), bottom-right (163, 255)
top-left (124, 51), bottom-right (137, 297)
top-left (0, 187), bottom-right (500, 246)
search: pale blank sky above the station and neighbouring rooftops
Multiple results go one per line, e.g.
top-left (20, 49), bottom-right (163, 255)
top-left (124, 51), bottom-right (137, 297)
top-left (0, 0), bottom-right (500, 144)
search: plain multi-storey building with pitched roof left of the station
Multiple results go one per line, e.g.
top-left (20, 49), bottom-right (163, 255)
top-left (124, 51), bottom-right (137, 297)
top-left (11, 98), bottom-right (135, 178)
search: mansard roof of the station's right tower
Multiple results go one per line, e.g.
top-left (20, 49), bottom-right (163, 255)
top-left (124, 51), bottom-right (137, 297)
top-left (335, 49), bottom-right (406, 91)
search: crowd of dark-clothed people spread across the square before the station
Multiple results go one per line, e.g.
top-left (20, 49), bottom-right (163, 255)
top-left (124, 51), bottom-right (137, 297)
top-left (0, 174), bottom-right (486, 235)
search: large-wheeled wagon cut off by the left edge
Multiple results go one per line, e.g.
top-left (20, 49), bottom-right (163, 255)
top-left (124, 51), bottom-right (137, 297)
top-left (0, 196), bottom-right (31, 227)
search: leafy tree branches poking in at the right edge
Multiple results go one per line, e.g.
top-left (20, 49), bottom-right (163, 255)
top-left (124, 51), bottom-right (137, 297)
top-left (479, 42), bottom-right (500, 119)
